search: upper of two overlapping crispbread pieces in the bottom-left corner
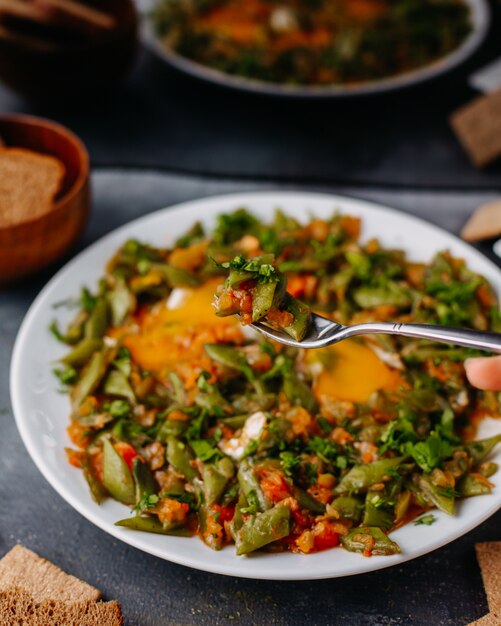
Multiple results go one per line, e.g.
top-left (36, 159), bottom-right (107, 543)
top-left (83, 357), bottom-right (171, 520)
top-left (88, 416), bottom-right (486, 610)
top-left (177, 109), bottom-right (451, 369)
top-left (0, 545), bottom-right (101, 604)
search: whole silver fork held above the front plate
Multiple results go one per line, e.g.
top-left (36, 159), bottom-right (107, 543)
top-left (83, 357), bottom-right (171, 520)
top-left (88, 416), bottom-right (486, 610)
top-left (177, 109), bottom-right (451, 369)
top-left (250, 313), bottom-right (501, 354)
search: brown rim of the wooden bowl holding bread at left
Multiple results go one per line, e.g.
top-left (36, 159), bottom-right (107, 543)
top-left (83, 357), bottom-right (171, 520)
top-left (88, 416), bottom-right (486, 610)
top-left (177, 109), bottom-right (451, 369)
top-left (0, 113), bottom-right (90, 234)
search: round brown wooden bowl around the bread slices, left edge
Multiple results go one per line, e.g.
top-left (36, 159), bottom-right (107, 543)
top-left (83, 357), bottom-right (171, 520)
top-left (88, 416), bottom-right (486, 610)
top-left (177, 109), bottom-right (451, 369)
top-left (0, 115), bottom-right (90, 282)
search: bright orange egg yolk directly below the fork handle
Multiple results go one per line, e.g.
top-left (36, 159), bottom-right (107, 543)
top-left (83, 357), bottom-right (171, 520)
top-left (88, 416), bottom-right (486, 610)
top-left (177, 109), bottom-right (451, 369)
top-left (308, 340), bottom-right (401, 402)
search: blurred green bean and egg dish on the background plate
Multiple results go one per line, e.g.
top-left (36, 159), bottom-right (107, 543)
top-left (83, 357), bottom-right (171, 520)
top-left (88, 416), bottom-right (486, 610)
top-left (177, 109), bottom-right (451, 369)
top-left (151, 0), bottom-right (472, 85)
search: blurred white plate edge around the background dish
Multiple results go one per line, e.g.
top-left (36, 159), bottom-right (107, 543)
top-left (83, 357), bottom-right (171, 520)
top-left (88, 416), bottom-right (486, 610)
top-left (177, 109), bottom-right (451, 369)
top-left (137, 0), bottom-right (490, 98)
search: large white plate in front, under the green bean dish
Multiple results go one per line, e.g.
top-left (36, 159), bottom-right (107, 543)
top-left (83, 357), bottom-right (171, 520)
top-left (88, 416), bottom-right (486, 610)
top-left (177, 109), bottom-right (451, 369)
top-left (11, 192), bottom-right (501, 580)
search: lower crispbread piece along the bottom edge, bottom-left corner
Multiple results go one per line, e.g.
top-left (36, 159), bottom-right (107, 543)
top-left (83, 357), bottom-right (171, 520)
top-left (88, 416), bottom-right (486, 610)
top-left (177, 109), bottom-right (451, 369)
top-left (0, 587), bottom-right (123, 626)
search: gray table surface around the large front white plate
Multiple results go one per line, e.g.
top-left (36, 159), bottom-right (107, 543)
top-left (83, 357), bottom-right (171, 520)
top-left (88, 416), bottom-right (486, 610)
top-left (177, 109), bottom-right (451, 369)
top-left (0, 170), bottom-right (501, 626)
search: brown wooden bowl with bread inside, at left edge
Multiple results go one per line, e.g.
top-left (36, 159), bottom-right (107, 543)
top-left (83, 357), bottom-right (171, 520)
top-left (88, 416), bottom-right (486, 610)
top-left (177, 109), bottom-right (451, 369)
top-left (0, 115), bottom-right (90, 282)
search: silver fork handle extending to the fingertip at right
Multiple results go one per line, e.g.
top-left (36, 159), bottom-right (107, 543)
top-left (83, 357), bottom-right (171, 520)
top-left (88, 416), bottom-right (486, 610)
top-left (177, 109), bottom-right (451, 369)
top-left (346, 322), bottom-right (501, 354)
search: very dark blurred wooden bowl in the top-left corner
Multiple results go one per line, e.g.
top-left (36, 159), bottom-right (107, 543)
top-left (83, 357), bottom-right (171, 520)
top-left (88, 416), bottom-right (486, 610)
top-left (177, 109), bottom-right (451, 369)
top-left (0, 0), bottom-right (138, 103)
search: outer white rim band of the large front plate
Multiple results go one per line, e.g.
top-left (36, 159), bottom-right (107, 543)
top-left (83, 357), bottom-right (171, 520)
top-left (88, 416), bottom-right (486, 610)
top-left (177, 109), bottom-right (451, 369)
top-left (10, 190), bottom-right (501, 581)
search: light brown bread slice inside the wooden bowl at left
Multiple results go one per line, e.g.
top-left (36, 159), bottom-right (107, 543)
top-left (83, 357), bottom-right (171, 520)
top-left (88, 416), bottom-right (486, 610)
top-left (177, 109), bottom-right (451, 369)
top-left (0, 147), bottom-right (65, 226)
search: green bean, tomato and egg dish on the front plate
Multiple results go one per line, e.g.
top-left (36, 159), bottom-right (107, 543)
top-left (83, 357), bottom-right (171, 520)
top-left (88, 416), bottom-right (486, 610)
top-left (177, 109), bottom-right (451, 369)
top-left (51, 208), bottom-right (501, 556)
